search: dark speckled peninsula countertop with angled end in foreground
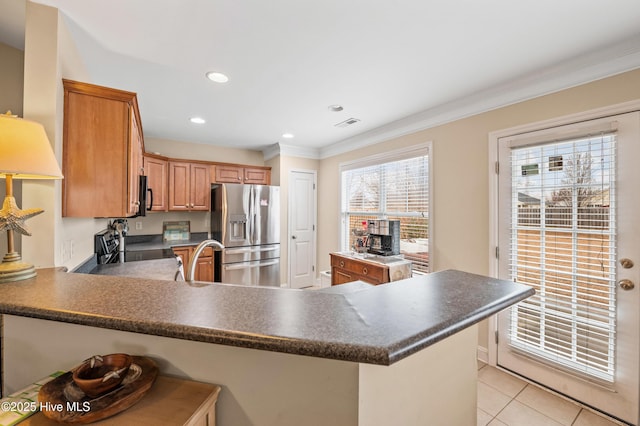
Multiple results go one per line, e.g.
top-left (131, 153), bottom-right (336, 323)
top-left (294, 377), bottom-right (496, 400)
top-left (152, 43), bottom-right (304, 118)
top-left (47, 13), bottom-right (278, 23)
top-left (0, 268), bottom-right (533, 365)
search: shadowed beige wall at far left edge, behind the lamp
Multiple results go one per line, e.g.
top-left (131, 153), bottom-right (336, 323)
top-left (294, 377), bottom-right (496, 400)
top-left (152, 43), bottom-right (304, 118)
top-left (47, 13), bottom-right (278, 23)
top-left (0, 43), bottom-right (24, 259)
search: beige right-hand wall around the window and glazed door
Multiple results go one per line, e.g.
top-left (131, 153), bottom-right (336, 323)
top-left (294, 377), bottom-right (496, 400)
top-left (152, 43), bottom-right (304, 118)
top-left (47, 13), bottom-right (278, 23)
top-left (318, 69), bottom-right (640, 347)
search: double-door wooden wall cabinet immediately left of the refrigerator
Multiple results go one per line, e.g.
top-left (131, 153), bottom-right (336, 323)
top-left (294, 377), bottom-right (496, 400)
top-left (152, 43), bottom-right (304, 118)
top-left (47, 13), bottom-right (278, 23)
top-left (169, 161), bottom-right (211, 211)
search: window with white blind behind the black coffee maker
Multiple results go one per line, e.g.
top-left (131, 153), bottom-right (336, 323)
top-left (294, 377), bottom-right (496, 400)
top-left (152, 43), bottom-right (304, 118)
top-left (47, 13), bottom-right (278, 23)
top-left (340, 144), bottom-right (429, 274)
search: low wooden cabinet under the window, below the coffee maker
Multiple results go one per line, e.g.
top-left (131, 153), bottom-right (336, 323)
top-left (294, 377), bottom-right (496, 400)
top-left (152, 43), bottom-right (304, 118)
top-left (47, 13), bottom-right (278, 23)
top-left (330, 253), bottom-right (389, 285)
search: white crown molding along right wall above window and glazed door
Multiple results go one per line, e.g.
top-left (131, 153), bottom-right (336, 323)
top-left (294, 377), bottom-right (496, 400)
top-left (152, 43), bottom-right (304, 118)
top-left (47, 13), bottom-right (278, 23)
top-left (319, 34), bottom-right (640, 159)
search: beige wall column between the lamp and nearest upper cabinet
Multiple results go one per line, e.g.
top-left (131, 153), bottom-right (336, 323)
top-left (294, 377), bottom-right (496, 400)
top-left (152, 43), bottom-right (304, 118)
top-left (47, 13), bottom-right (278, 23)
top-left (22, 2), bottom-right (106, 268)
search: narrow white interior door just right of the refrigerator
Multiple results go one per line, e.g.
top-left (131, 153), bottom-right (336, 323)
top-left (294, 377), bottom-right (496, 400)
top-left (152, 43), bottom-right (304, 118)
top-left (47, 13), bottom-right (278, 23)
top-left (289, 170), bottom-right (316, 288)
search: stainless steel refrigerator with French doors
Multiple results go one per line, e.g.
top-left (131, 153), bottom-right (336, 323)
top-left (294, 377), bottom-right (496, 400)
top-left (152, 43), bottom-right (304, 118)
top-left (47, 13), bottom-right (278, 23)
top-left (211, 184), bottom-right (280, 287)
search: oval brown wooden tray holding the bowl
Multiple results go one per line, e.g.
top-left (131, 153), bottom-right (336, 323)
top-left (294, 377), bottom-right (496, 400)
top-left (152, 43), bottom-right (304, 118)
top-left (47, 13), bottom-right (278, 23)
top-left (38, 356), bottom-right (158, 423)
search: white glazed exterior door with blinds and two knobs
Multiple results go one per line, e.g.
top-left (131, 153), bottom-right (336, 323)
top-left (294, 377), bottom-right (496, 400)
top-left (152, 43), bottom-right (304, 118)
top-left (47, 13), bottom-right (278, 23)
top-left (497, 112), bottom-right (640, 425)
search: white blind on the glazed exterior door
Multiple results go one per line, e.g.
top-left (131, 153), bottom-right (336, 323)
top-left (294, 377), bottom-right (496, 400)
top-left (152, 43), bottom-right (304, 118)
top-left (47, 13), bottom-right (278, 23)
top-left (509, 131), bottom-right (616, 382)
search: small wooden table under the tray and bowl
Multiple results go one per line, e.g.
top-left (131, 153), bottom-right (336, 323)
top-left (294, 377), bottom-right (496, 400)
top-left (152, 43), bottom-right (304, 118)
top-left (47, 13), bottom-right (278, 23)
top-left (20, 376), bottom-right (220, 426)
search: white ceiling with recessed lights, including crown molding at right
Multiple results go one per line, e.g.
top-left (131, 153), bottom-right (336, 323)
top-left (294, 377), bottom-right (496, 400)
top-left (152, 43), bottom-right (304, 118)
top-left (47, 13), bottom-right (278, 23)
top-left (0, 0), bottom-right (640, 158)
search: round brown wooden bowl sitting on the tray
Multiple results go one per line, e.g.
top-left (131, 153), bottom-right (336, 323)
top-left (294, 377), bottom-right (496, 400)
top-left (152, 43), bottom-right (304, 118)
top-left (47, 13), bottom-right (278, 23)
top-left (73, 354), bottom-right (132, 398)
